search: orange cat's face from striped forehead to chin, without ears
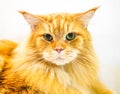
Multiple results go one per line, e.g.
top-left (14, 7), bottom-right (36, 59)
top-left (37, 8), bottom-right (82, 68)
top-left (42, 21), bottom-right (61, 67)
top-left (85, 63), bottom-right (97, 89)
top-left (36, 18), bottom-right (83, 65)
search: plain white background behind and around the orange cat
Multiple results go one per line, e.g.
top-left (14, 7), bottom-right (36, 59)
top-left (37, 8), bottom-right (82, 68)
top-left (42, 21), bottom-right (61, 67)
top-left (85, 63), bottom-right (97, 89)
top-left (0, 0), bottom-right (120, 94)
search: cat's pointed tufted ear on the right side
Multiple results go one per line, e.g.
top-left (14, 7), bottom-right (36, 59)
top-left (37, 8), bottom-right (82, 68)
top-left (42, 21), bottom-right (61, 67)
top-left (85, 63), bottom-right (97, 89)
top-left (74, 7), bottom-right (99, 28)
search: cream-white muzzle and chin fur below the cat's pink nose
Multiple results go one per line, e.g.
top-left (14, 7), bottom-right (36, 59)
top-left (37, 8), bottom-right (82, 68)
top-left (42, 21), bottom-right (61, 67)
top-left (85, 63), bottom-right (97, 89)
top-left (43, 50), bottom-right (78, 65)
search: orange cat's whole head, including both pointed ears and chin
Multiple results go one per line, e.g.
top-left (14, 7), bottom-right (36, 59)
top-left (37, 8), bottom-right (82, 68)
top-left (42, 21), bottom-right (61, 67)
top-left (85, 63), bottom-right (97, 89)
top-left (21, 8), bottom-right (97, 65)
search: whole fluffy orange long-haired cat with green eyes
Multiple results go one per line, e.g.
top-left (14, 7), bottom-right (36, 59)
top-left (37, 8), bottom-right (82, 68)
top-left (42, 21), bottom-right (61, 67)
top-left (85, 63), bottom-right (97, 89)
top-left (0, 7), bottom-right (113, 94)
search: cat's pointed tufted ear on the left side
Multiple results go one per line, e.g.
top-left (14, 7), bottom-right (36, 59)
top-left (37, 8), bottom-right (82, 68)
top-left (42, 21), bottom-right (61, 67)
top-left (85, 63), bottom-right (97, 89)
top-left (19, 11), bottom-right (44, 29)
